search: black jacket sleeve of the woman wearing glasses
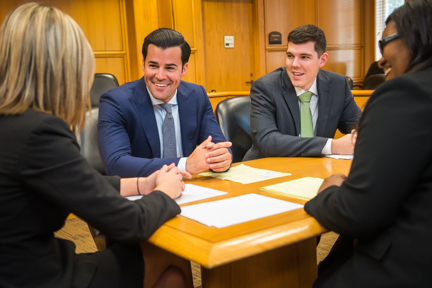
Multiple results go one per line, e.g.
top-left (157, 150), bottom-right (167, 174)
top-left (305, 77), bottom-right (432, 237)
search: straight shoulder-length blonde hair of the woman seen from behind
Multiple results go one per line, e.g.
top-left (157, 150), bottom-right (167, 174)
top-left (0, 3), bottom-right (95, 130)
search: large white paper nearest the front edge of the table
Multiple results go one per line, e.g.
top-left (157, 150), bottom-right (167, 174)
top-left (181, 194), bottom-right (303, 228)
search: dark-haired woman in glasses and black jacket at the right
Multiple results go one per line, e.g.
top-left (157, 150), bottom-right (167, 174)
top-left (305, 0), bottom-right (432, 287)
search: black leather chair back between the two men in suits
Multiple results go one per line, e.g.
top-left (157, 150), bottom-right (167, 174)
top-left (215, 96), bottom-right (252, 163)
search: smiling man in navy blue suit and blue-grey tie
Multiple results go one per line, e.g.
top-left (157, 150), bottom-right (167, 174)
top-left (98, 28), bottom-right (232, 177)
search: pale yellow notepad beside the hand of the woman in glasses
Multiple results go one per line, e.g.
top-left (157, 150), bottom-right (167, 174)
top-left (260, 177), bottom-right (324, 200)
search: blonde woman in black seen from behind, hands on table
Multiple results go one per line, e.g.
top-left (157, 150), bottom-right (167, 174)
top-left (0, 3), bottom-right (189, 287)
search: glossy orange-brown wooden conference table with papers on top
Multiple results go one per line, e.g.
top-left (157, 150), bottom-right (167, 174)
top-left (144, 157), bottom-right (352, 288)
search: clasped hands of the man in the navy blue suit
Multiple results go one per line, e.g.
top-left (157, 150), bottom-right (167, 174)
top-left (186, 136), bottom-right (232, 174)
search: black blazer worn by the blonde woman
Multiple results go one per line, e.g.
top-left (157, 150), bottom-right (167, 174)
top-left (0, 109), bottom-right (180, 287)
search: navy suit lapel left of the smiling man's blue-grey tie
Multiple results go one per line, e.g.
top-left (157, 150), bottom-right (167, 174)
top-left (130, 78), bottom-right (161, 158)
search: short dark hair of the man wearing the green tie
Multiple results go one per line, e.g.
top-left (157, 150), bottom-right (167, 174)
top-left (288, 24), bottom-right (327, 57)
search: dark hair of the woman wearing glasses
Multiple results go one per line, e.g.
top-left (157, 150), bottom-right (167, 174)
top-left (386, 0), bottom-right (432, 73)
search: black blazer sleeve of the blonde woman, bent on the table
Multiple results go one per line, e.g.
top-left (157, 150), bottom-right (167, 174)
top-left (20, 117), bottom-right (180, 242)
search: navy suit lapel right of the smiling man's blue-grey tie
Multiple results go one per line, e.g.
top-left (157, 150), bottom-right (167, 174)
top-left (177, 82), bottom-right (199, 157)
